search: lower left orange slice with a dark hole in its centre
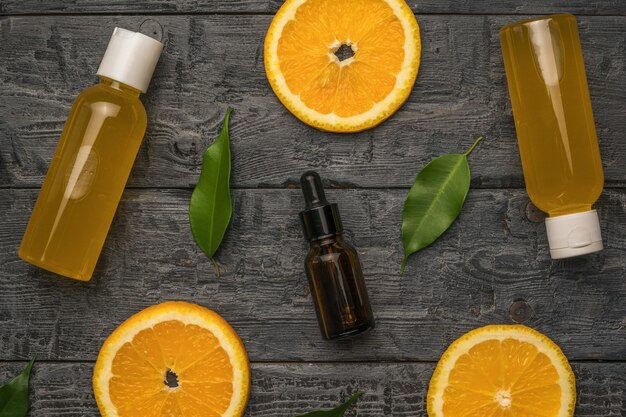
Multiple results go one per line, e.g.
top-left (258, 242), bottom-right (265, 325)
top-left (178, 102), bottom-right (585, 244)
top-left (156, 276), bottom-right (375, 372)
top-left (93, 302), bottom-right (250, 417)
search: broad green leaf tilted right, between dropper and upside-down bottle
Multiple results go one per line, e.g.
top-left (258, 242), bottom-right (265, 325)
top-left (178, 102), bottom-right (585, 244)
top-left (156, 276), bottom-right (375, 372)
top-left (400, 136), bottom-right (483, 273)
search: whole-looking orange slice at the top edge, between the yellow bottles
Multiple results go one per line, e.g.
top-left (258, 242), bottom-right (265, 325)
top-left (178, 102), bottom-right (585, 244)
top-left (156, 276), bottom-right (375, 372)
top-left (265, 0), bottom-right (421, 132)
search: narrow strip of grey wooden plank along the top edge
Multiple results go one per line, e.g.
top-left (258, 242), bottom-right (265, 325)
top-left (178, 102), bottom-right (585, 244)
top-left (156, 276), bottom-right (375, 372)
top-left (0, 0), bottom-right (626, 15)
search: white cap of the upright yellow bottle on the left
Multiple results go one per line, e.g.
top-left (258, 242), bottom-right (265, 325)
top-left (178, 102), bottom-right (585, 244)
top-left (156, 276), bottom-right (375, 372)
top-left (96, 28), bottom-right (163, 93)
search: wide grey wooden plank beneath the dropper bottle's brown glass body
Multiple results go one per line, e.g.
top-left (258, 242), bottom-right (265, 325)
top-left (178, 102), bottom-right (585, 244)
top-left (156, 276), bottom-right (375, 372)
top-left (0, 189), bottom-right (626, 361)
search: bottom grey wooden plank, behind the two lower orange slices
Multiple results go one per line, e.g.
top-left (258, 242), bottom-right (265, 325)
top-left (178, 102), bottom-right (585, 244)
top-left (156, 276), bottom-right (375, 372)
top-left (0, 362), bottom-right (626, 417)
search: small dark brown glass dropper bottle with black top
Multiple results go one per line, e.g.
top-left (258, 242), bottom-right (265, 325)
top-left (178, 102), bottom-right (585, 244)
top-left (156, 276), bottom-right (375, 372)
top-left (300, 171), bottom-right (374, 340)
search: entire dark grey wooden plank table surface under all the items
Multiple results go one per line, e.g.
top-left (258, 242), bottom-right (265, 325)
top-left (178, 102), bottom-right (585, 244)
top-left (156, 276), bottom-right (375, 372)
top-left (0, 0), bottom-right (626, 417)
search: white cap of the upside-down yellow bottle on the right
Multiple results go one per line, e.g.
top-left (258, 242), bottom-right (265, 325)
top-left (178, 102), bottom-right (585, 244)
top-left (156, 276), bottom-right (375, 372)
top-left (546, 210), bottom-right (603, 259)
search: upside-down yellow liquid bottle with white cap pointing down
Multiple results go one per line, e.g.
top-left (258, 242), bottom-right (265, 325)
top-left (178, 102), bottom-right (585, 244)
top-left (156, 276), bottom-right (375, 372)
top-left (500, 14), bottom-right (604, 259)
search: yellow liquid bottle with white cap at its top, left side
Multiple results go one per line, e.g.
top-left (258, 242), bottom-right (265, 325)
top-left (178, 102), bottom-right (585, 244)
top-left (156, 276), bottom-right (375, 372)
top-left (18, 28), bottom-right (163, 281)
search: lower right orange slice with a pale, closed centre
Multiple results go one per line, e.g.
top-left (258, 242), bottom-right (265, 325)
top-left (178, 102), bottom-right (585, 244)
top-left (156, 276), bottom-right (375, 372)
top-left (428, 325), bottom-right (576, 417)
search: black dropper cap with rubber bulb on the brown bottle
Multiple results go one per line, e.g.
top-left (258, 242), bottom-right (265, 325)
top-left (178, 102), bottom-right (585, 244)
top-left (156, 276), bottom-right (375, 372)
top-left (300, 171), bottom-right (343, 241)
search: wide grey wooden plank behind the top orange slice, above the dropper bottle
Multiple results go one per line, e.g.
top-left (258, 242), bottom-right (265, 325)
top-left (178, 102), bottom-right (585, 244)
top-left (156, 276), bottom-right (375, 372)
top-left (0, 15), bottom-right (626, 187)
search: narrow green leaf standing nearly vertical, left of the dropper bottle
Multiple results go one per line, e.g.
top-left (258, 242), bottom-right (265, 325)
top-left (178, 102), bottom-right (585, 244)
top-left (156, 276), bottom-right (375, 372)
top-left (189, 108), bottom-right (233, 277)
